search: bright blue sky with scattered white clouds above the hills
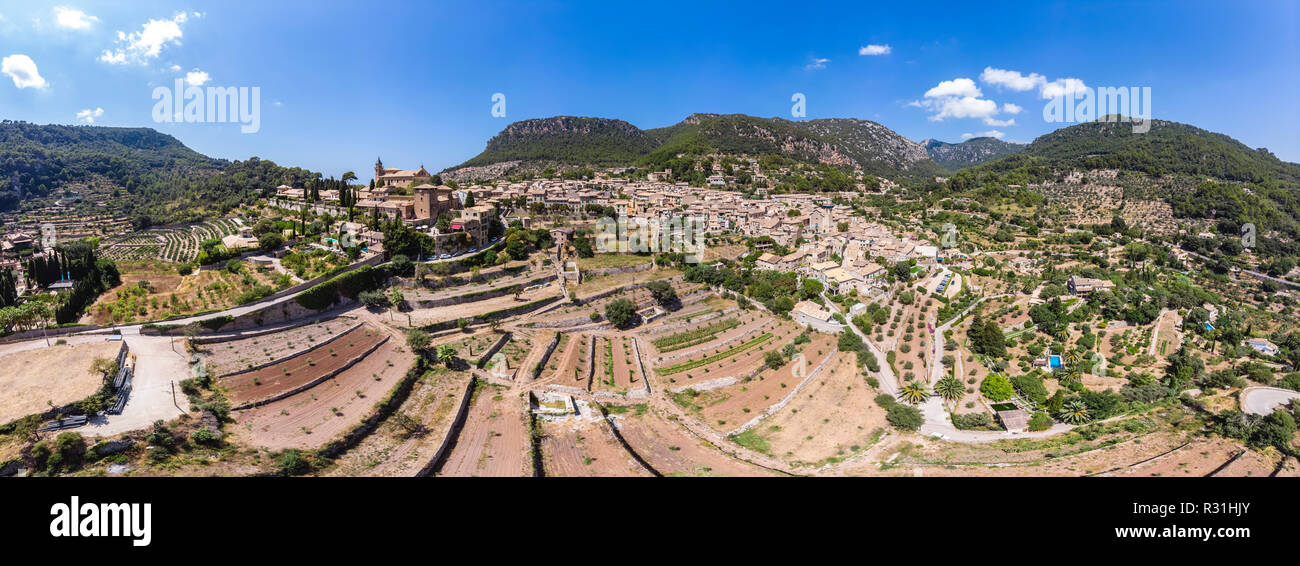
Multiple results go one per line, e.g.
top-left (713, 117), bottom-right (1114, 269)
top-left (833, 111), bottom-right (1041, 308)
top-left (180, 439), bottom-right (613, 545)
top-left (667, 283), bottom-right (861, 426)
top-left (0, 0), bottom-right (1300, 178)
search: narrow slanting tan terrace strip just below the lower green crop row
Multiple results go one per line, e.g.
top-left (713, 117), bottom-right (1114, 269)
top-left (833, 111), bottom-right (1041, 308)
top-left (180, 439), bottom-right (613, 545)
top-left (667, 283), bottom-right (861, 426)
top-left (654, 323), bottom-right (800, 389)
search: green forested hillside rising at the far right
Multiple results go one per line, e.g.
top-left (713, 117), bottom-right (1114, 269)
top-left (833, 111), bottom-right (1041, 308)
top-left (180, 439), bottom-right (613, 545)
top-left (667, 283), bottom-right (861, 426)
top-left (949, 120), bottom-right (1300, 261)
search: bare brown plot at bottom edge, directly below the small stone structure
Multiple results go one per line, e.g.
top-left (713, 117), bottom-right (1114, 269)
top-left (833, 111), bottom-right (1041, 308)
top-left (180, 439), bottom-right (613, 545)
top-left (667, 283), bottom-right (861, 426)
top-left (538, 407), bottom-right (651, 478)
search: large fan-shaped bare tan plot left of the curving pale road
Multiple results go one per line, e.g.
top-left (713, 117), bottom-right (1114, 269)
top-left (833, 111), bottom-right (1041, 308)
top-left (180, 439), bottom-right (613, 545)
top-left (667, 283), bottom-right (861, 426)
top-left (753, 353), bottom-right (889, 466)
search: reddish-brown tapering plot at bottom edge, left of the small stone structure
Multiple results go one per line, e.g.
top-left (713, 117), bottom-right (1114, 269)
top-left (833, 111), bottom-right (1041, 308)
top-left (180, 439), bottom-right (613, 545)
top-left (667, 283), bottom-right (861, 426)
top-left (434, 381), bottom-right (530, 476)
